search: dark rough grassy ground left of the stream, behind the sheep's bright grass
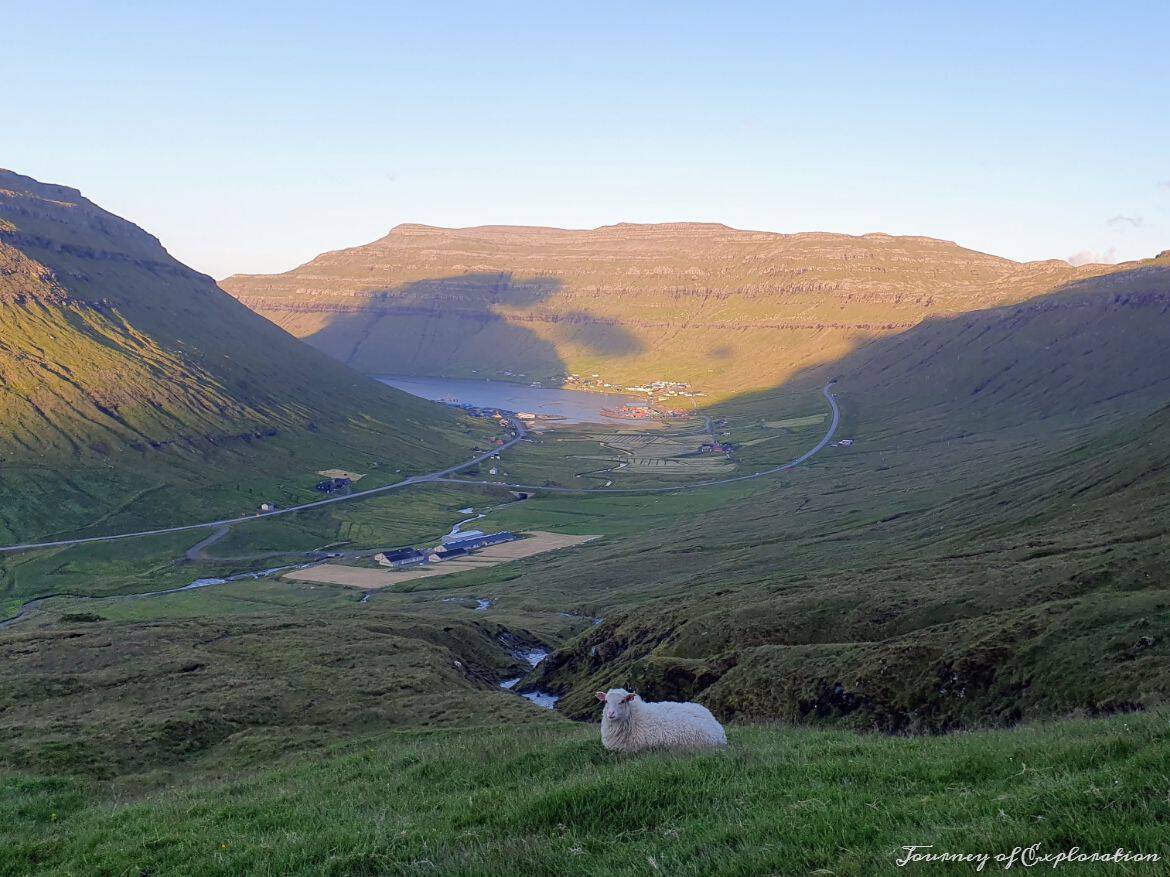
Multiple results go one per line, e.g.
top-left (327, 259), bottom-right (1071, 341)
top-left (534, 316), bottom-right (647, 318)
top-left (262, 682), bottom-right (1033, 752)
top-left (0, 582), bottom-right (566, 781)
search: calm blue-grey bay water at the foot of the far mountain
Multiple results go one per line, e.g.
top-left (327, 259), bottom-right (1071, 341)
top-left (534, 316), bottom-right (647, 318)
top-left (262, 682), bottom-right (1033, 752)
top-left (378, 375), bottom-right (642, 423)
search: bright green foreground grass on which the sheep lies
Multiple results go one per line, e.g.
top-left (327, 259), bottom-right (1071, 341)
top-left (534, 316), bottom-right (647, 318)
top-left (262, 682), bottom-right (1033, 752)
top-left (0, 714), bottom-right (1170, 876)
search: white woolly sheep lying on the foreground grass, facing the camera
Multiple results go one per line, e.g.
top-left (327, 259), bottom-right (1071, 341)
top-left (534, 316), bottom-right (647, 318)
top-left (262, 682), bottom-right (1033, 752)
top-left (597, 689), bottom-right (728, 752)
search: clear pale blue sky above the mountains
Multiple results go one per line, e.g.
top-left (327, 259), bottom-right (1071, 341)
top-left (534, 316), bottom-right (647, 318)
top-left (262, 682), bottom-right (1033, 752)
top-left (0, 0), bottom-right (1170, 278)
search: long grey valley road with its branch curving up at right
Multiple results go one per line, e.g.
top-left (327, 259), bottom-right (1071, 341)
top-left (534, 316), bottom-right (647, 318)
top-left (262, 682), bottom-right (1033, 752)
top-left (0, 381), bottom-right (841, 554)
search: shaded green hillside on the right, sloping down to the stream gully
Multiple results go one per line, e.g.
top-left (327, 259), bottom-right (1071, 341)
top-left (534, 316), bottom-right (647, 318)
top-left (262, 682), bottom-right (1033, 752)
top-left (521, 261), bottom-right (1170, 732)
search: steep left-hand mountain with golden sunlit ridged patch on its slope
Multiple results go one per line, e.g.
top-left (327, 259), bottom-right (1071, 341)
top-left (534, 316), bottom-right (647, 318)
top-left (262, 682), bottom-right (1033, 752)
top-left (0, 171), bottom-right (479, 541)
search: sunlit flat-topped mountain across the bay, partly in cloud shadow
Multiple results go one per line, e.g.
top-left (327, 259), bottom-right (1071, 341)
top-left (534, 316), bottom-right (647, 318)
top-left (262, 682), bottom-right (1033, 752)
top-left (221, 223), bottom-right (1101, 396)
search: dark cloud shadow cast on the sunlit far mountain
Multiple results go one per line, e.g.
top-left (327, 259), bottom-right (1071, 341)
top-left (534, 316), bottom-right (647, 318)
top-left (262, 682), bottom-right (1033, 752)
top-left (296, 272), bottom-right (642, 378)
